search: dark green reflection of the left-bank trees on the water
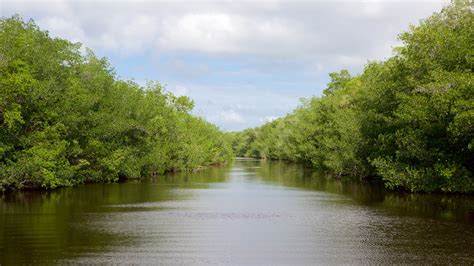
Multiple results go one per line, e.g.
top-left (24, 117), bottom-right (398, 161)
top-left (0, 164), bottom-right (228, 265)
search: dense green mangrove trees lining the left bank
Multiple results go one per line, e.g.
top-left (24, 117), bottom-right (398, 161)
top-left (0, 16), bottom-right (232, 191)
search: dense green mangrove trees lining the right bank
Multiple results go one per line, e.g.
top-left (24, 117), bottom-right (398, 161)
top-left (231, 1), bottom-right (474, 193)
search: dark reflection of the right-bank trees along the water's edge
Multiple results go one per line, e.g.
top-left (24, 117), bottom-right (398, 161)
top-left (245, 161), bottom-right (474, 224)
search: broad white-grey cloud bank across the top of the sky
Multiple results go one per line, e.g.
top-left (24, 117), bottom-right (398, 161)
top-left (1, 0), bottom-right (446, 61)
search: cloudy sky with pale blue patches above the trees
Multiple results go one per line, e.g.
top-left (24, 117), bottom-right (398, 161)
top-left (0, 0), bottom-right (447, 131)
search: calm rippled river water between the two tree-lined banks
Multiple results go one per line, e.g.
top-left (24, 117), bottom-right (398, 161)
top-left (0, 161), bottom-right (474, 265)
